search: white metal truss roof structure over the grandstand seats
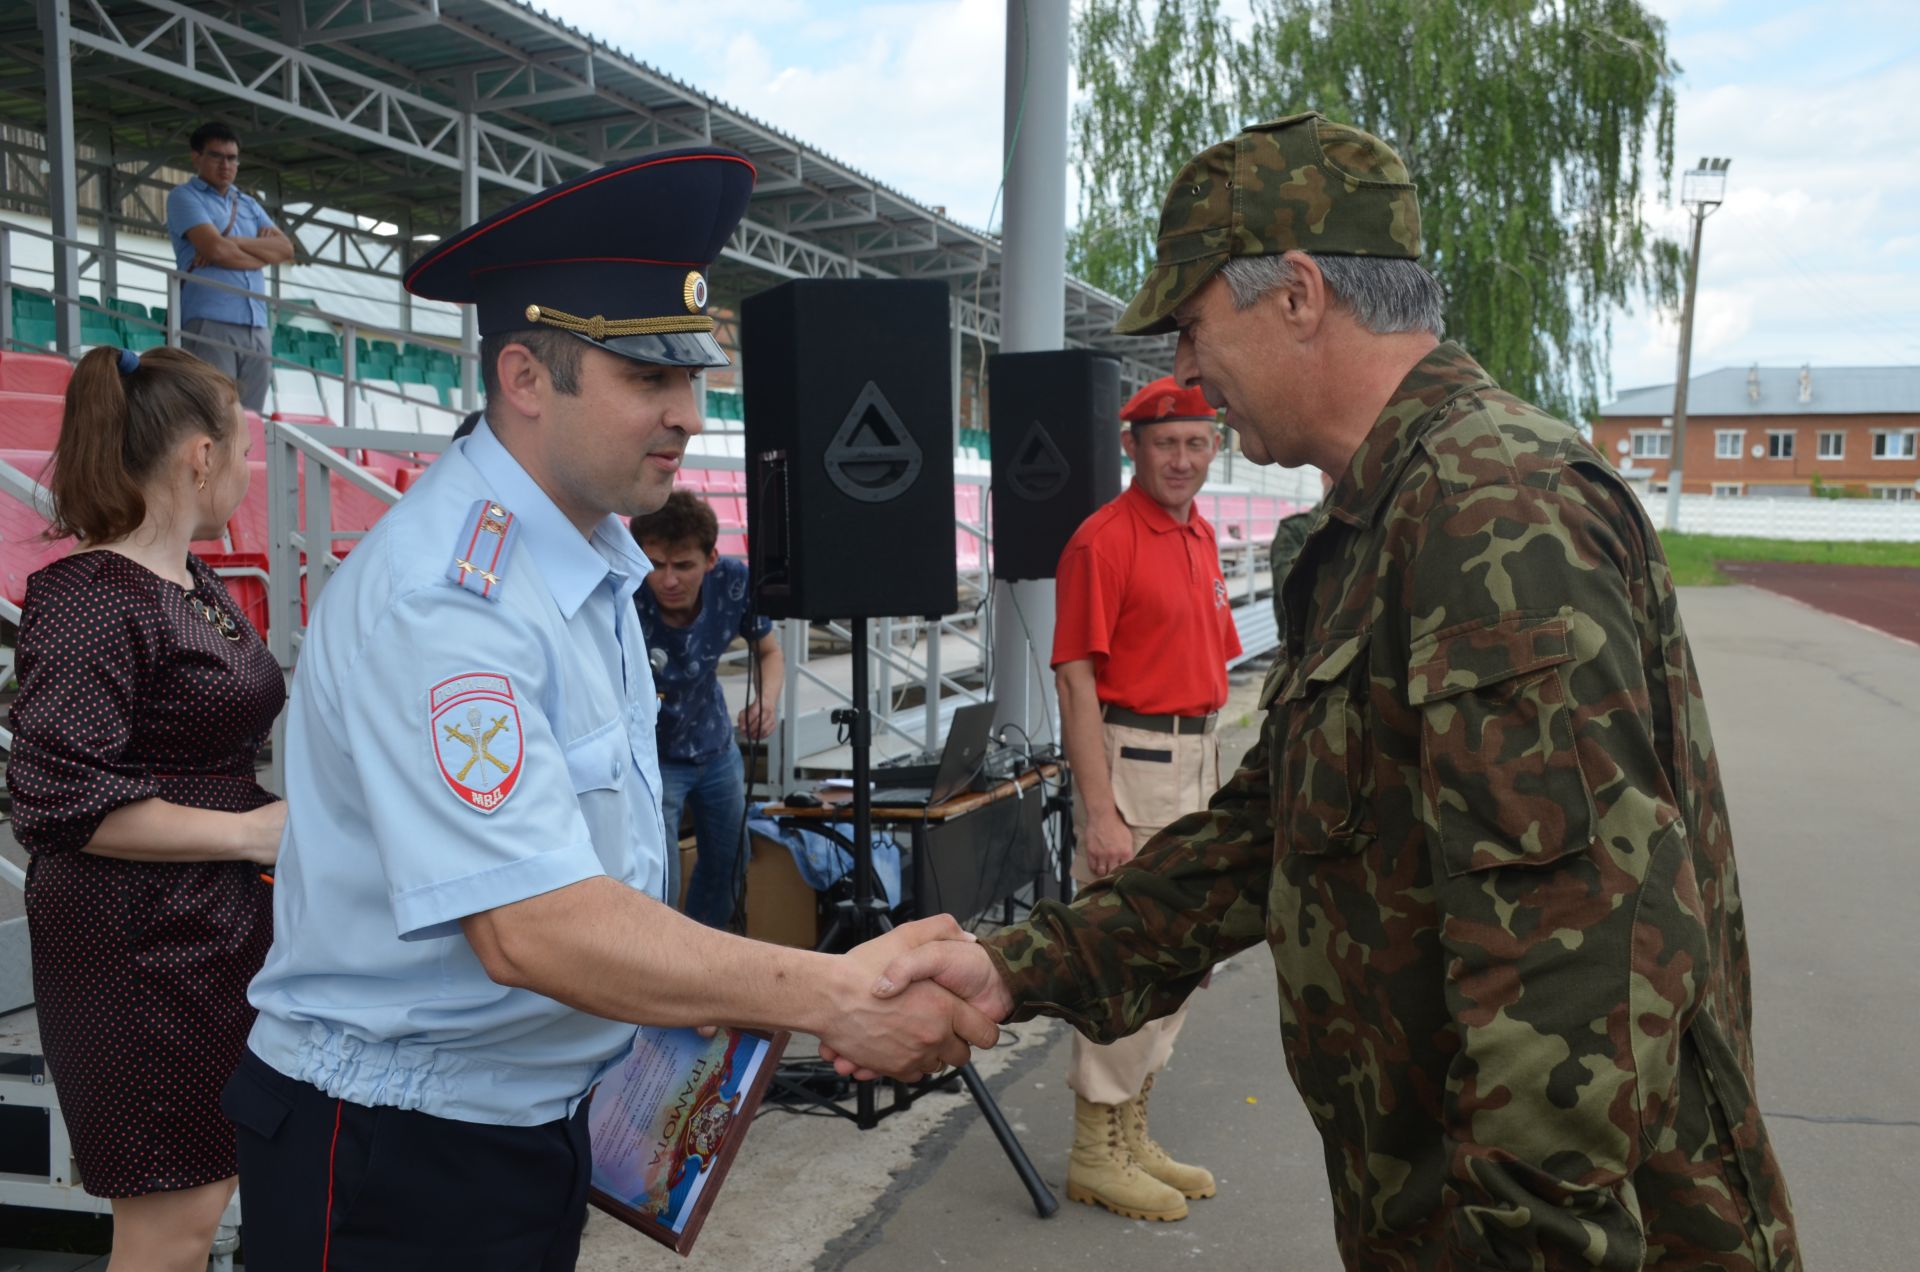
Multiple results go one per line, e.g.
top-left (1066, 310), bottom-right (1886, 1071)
top-left (8, 0), bottom-right (1171, 374)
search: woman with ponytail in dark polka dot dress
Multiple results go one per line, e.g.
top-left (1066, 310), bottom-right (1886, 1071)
top-left (6, 348), bottom-right (286, 1268)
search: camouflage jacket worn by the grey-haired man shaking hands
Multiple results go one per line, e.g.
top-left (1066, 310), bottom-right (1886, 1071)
top-left (989, 344), bottom-right (1799, 1272)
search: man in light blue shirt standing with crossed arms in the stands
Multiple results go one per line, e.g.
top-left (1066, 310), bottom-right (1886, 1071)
top-left (167, 123), bottom-right (294, 411)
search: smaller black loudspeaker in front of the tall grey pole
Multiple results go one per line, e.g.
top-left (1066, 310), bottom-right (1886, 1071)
top-left (987, 350), bottom-right (1121, 582)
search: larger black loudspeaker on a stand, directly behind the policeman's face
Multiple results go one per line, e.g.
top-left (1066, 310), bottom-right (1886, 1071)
top-left (739, 279), bottom-right (960, 619)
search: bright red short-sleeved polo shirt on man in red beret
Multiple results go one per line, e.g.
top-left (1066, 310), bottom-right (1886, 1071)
top-left (1052, 484), bottom-right (1240, 715)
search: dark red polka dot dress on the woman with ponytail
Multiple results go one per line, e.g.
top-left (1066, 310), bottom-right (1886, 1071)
top-left (6, 551), bottom-right (286, 1197)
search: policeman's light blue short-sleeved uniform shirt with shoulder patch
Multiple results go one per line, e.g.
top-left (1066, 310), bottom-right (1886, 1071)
top-left (248, 423), bottom-right (666, 1126)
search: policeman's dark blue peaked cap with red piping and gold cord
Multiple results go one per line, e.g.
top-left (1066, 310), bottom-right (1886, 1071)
top-left (405, 146), bottom-right (755, 367)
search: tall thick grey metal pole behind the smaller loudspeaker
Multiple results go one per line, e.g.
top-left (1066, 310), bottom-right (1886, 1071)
top-left (989, 0), bottom-right (1069, 746)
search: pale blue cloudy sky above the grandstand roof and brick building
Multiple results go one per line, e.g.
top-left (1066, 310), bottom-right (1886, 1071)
top-left (553, 0), bottom-right (1920, 399)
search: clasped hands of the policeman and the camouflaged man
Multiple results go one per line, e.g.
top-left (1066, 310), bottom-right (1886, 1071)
top-left (818, 915), bottom-right (1014, 1082)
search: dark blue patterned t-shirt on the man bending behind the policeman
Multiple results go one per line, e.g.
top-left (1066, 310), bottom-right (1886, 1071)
top-left (637, 557), bottom-right (774, 763)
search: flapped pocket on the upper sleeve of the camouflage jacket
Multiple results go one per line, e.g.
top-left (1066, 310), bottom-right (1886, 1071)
top-left (1407, 613), bottom-right (1596, 874)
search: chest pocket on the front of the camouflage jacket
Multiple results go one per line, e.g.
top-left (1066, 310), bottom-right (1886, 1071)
top-left (1267, 632), bottom-right (1373, 857)
